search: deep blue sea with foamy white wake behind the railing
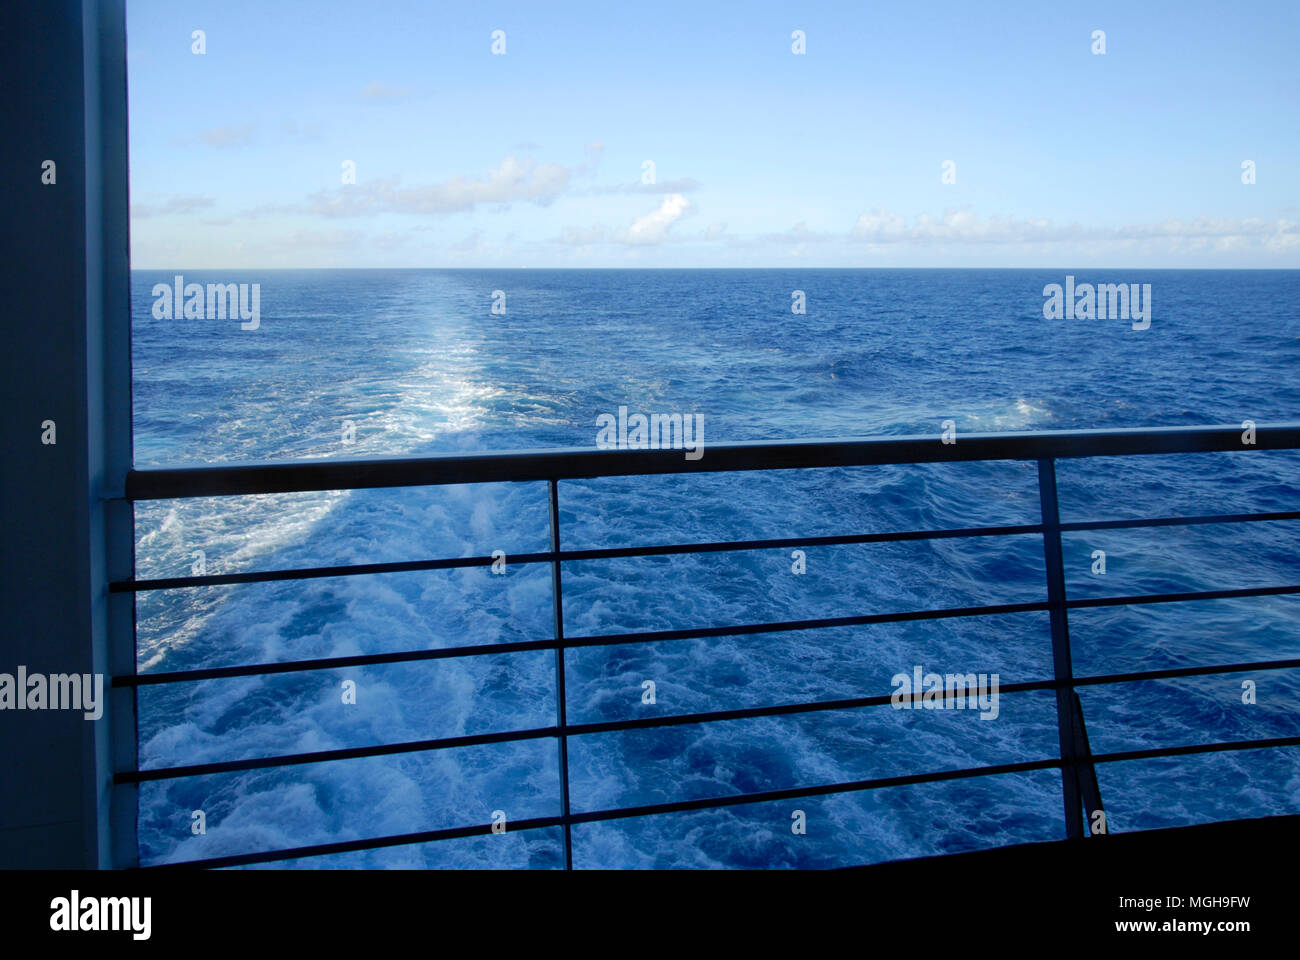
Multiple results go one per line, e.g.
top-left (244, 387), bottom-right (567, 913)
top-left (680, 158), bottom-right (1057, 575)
top-left (133, 269), bottom-right (1300, 866)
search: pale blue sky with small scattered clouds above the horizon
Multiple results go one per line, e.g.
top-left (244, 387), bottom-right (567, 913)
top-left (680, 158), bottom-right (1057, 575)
top-left (127, 0), bottom-right (1300, 269)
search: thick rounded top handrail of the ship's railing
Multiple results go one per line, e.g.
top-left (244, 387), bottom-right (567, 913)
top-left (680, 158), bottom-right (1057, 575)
top-left (125, 423), bottom-right (1300, 501)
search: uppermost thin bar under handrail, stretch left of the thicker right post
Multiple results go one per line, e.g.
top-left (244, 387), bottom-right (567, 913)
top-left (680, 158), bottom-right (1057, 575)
top-left (109, 524), bottom-right (1043, 593)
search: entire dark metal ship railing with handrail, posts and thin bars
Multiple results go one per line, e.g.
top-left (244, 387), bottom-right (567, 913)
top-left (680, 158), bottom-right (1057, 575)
top-left (111, 424), bottom-right (1300, 869)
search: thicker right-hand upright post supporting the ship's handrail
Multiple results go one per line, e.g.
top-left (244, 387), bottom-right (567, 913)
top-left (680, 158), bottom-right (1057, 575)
top-left (1039, 457), bottom-right (1083, 840)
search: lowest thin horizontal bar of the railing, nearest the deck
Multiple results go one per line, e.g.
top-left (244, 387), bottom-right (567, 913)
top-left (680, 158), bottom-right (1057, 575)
top-left (147, 736), bottom-right (1300, 869)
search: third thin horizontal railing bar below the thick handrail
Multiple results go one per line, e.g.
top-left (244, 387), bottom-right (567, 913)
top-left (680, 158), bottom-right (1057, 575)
top-left (114, 660), bottom-right (1300, 783)
